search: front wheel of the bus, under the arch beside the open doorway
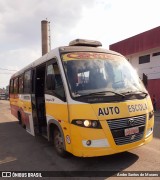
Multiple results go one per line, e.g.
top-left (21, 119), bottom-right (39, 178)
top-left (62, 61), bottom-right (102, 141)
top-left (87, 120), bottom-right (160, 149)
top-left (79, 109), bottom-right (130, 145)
top-left (53, 128), bottom-right (67, 157)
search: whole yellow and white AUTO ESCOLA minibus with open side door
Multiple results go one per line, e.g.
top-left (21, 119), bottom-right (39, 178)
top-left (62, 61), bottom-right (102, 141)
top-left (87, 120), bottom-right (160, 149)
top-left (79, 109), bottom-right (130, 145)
top-left (10, 39), bottom-right (154, 157)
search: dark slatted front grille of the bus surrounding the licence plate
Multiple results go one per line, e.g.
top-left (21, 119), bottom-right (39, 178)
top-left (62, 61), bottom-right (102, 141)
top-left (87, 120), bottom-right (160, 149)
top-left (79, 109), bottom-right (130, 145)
top-left (107, 115), bottom-right (146, 145)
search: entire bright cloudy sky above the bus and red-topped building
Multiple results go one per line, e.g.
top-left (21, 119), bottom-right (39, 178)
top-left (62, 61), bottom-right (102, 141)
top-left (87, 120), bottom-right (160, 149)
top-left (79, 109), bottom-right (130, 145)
top-left (0, 0), bottom-right (160, 88)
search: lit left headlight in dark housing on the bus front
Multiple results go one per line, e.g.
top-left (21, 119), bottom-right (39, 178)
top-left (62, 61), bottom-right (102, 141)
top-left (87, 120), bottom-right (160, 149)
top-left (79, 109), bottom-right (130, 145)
top-left (72, 119), bottom-right (102, 129)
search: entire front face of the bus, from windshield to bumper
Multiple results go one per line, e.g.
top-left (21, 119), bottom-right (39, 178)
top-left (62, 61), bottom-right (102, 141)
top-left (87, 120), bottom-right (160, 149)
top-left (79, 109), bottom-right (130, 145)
top-left (61, 48), bottom-right (154, 157)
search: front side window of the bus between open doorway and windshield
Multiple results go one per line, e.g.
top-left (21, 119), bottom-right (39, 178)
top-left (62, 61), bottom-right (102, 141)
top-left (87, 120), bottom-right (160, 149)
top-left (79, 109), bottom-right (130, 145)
top-left (46, 62), bottom-right (65, 101)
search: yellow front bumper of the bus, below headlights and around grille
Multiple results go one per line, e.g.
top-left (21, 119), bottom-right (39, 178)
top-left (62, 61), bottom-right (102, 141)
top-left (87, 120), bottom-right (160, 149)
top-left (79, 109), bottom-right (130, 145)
top-left (71, 114), bottom-right (154, 157)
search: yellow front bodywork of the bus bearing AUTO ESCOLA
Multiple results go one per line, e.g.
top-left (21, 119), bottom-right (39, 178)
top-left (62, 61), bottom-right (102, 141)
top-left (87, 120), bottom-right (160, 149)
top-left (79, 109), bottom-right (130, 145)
top-left (66, 98), bottom-right (154, 157)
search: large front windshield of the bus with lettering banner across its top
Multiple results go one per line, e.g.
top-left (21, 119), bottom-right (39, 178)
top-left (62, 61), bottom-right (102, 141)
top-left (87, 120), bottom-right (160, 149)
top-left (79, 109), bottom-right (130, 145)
top-left (62, 52), bottom-right (146, 97)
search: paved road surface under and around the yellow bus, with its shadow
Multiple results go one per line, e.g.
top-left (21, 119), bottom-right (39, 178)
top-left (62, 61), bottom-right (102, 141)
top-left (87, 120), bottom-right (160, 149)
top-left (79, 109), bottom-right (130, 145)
top-left (0, 100), bottom-right (160, 179)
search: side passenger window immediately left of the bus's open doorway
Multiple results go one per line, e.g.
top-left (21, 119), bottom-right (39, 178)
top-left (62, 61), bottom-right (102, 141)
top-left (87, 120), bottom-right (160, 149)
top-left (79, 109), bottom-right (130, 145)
top-left (24, 70), bottom-right (32, 94)
